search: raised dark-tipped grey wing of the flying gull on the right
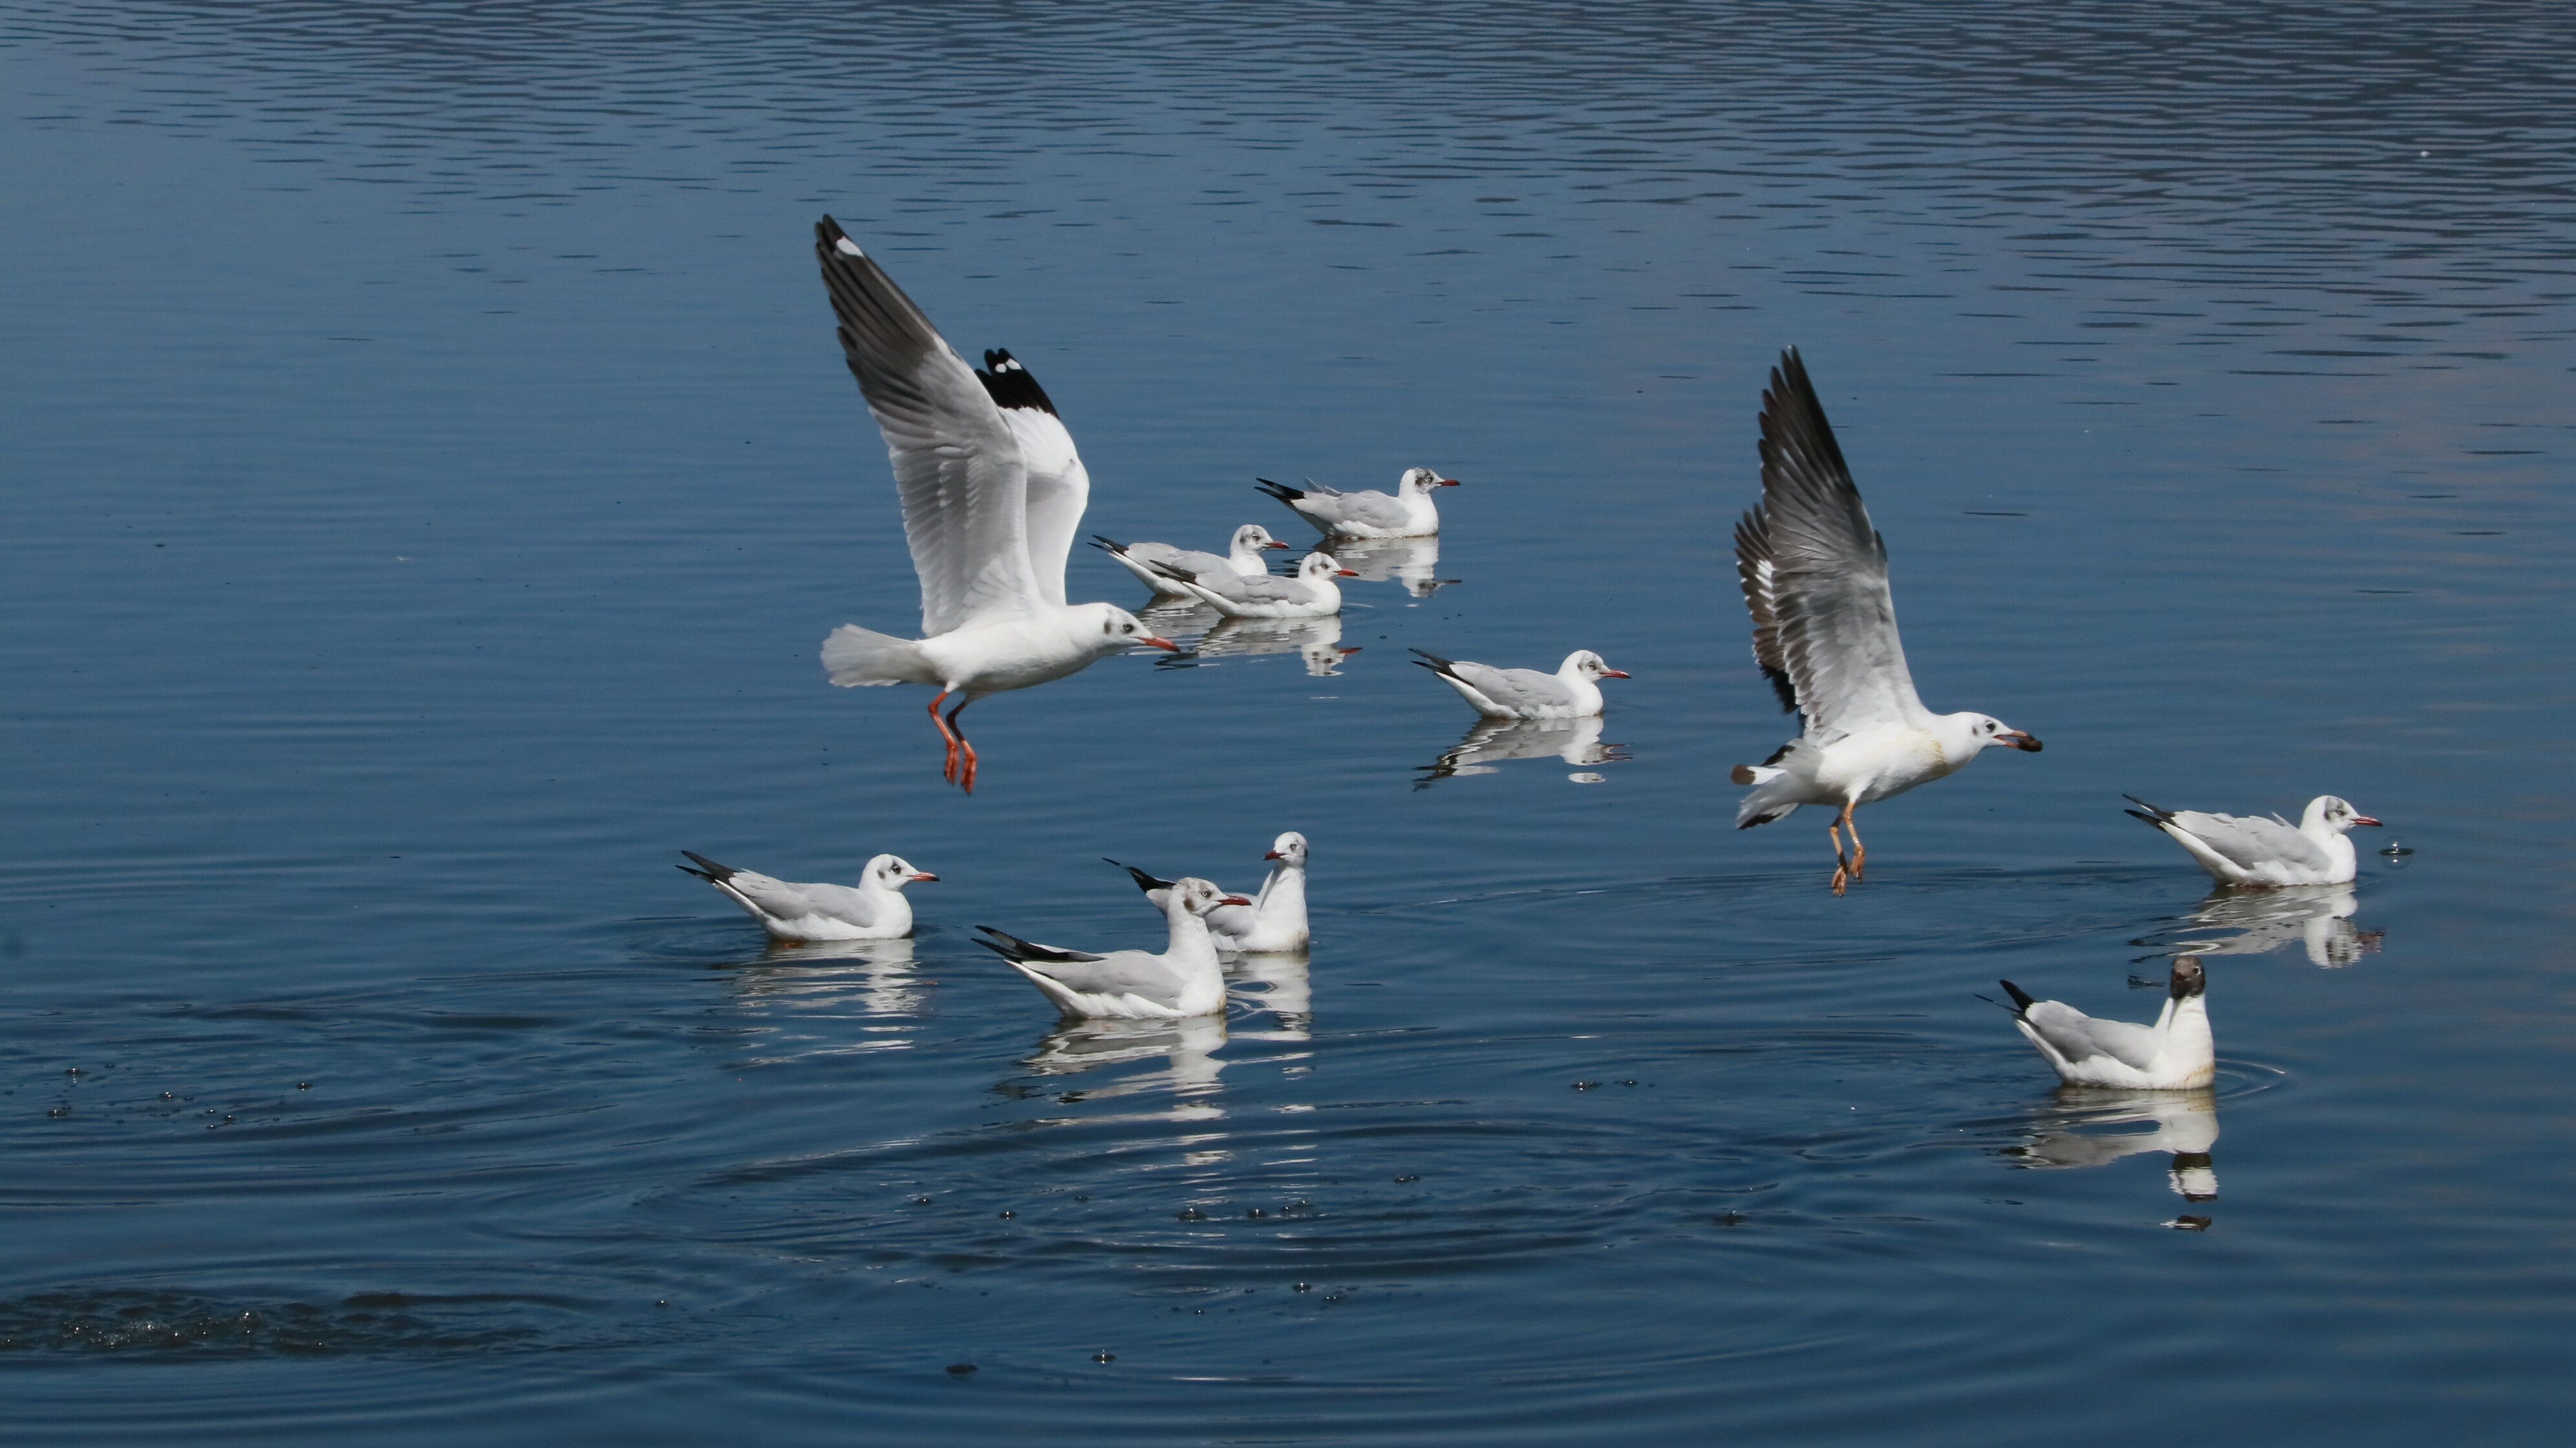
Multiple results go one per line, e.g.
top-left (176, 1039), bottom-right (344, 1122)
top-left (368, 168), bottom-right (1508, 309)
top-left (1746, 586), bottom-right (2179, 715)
top-left (1736, 348), bottom-right (1927, 740)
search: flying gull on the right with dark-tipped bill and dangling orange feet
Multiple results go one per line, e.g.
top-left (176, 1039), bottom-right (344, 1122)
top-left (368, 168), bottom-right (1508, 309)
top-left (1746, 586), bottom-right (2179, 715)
top-left (1733, 348), bottom-right (2040, 894)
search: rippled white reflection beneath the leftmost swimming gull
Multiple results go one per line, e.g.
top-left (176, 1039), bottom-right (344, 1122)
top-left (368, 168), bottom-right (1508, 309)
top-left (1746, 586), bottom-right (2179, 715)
top-left (724, 941), bottom-right (930, 1064)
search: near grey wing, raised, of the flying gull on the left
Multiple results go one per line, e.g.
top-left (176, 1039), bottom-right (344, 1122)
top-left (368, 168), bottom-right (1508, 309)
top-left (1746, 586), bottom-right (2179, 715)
top-left (814, 217), bottom-right (1040, 636)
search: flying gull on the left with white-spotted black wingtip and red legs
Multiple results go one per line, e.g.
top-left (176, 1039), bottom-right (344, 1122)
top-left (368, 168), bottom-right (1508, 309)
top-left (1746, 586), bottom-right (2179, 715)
top-left (814, 217), bottom-right (1180, 794)
